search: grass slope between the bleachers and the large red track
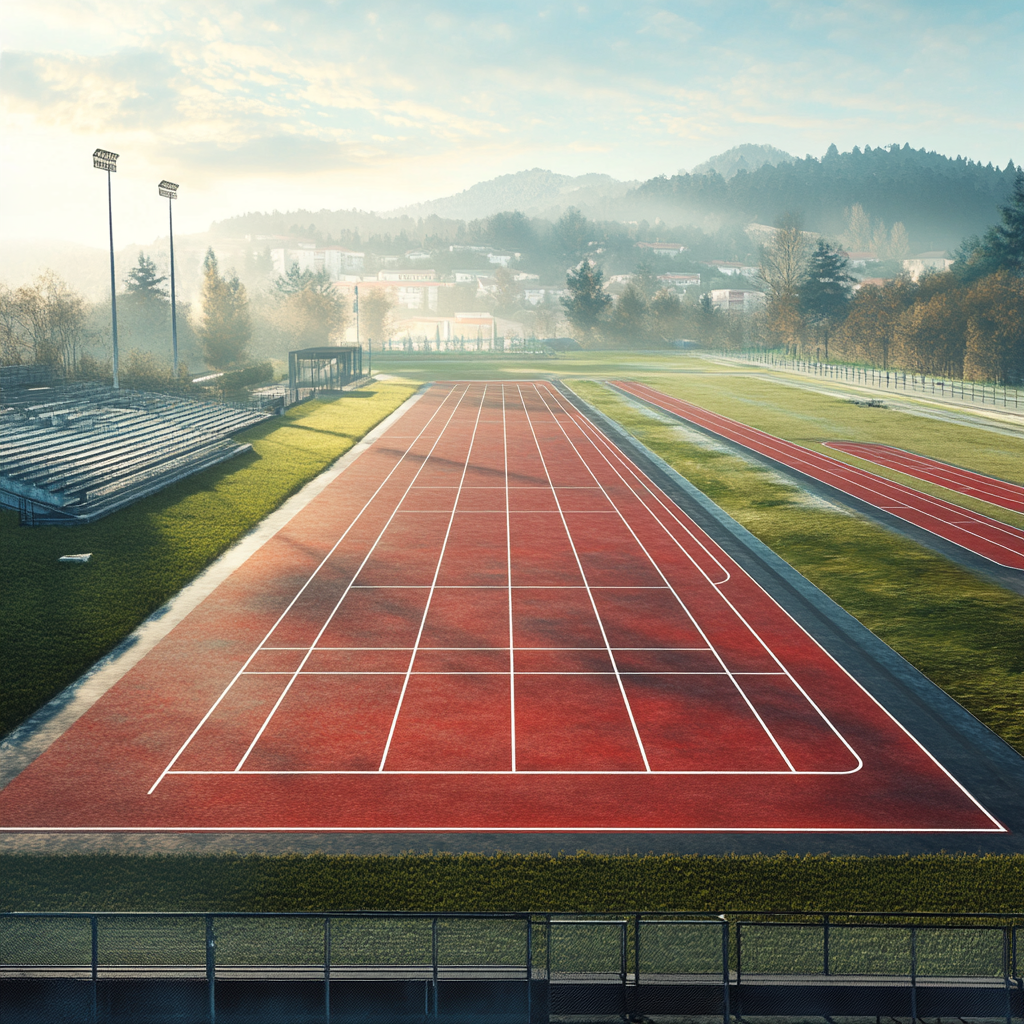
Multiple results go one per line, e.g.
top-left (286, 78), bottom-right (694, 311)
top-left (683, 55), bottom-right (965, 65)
top-left (0, 384), bottom-right (413, 734)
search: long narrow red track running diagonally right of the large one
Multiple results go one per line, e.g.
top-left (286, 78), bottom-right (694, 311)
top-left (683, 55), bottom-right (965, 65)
top-left (610, 381), bottom-right (1024, 569)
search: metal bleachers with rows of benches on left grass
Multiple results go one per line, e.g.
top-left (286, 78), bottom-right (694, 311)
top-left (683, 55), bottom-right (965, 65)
top-left (0, 367), bottom-right (274, 525)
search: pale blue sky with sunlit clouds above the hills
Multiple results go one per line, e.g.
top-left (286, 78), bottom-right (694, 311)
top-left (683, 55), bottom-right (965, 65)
top-left (0, 0), bottom-right (1024, 247)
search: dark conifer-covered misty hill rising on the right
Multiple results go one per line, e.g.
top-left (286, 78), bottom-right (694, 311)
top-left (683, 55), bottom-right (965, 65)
top-left (620, 144), bottom-right (1017, 251)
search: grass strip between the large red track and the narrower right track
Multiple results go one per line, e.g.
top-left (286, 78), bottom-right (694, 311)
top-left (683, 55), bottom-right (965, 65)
top-left (573, 381), bottom-right (1024, 753)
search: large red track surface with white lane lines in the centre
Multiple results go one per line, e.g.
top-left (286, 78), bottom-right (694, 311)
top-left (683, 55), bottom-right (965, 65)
top-left (0, 382), bottom-right (1002, 831)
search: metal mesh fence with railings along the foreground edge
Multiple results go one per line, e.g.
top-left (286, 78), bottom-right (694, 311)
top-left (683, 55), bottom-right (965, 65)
top-left (0, 911), bottom-right (1024, 1024)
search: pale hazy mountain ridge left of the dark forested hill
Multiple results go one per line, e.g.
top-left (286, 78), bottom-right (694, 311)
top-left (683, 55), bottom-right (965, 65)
top-left (380, 167), bottom-right (639, 220)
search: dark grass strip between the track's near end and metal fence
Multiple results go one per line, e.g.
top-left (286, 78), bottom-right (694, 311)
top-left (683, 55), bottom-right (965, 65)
top-left (0, 853), bottom-right (1024, 913)
